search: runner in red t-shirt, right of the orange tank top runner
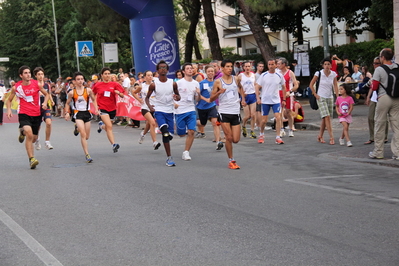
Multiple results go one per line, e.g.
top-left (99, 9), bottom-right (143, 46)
top-left (93, 67), bottom-right (125, 153)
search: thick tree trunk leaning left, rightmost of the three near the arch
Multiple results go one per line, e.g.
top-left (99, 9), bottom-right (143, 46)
top-left (237, 0), bottom-right (275, 60)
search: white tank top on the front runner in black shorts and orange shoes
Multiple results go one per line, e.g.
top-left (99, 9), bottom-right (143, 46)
top-left (219, 76), bottom-right (240, 114)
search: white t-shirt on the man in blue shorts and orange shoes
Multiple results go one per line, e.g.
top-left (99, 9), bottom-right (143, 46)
top-left (256, 71), bottom-right (285, 104)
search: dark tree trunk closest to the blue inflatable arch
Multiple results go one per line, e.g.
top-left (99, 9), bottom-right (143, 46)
top-left (184, 0), bottom-right (201, 62)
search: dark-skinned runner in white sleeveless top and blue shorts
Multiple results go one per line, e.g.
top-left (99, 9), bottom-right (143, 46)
top-left (145, 60), bottom-right (180, 166)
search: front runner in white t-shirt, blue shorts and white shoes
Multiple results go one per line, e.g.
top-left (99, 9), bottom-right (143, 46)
top-left (175, 63), bottom-right (200, 161)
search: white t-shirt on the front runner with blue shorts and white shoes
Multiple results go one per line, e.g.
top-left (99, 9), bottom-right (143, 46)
top-left (175, 78), bottom-right (199, 114)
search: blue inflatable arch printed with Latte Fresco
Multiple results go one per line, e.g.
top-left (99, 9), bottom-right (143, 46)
top-left (100, 0), bottom-right (180, 78)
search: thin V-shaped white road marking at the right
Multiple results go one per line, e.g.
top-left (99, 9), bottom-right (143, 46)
top-left (285, 175), bottom-right (399, 203)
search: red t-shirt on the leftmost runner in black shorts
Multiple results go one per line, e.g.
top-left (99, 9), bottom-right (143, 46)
top-left (15, 79), bottom-right (41, 116)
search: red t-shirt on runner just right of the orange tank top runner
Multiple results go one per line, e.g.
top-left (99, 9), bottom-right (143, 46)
top-left (92, 81), bottom-right (125, 112)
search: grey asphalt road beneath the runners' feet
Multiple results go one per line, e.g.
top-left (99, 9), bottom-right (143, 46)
top-left (0, 118), bottom-right (399, 266)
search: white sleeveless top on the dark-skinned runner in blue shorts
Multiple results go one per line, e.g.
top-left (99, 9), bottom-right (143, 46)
top-left (154, 78), bottom-right (173, 113)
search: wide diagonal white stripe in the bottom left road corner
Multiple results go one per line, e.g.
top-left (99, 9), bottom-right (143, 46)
top-left (0, 209), bottom-right (63, 266)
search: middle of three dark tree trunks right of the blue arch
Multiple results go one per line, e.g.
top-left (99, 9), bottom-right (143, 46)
top-left (202, 0), bottom-right (223, 60)
